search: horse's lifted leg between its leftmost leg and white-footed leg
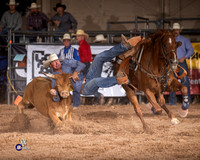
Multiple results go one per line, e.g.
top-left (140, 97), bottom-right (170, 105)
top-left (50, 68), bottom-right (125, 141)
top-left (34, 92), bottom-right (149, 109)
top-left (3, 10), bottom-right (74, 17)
top-left (144, 89), bottom-right (162, 114)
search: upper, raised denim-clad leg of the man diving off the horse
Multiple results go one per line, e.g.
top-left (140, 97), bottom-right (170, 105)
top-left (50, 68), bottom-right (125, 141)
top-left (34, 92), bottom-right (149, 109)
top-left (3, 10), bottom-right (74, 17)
top-left (86, 43), bottom-right (127, 80)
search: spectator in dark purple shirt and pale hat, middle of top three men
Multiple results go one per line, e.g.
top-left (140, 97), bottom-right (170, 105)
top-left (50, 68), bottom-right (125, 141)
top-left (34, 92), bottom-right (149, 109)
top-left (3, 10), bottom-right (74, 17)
top-left (26, 3), bottom-right (49, 31)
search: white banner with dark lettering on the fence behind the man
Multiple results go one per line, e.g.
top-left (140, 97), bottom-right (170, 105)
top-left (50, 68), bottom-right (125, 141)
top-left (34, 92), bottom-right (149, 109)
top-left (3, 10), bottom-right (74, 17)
top-left (27, 45), bottom-right (125, 97)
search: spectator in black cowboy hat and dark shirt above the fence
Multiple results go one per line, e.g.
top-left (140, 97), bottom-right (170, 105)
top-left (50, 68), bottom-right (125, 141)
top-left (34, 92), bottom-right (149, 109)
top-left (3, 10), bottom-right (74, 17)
top-left (52, 3), bottom-right (78, 32)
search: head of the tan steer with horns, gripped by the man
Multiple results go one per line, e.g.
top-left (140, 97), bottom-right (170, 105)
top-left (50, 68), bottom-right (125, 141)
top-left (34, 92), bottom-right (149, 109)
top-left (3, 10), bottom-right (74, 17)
top-left (45, 73), bottom-right (73, 98)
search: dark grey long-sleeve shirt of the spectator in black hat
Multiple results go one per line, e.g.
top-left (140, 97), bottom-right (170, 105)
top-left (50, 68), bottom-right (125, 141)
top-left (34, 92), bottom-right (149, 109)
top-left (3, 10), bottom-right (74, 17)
top-left (52, 12), bottom-right (78, 32)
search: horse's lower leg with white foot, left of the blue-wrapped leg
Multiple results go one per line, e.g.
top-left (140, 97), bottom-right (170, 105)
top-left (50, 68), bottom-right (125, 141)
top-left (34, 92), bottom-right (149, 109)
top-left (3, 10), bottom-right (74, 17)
top-left (158, 94), bottom-right (180, 124)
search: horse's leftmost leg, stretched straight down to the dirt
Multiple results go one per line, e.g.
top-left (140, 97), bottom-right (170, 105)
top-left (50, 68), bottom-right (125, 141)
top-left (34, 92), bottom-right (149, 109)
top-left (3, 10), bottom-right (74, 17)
top-left (122, 85), bottom-right (152, 132)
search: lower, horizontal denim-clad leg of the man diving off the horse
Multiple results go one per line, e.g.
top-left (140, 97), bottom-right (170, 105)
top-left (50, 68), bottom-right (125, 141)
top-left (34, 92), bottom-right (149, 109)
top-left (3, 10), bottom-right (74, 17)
top-left (82, 77), bottom-right (118, 98)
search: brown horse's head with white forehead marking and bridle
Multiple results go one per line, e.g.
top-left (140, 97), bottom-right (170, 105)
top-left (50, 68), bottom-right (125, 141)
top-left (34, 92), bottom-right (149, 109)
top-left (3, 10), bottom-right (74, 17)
top-left (154, 30), bottom-right (182, 70)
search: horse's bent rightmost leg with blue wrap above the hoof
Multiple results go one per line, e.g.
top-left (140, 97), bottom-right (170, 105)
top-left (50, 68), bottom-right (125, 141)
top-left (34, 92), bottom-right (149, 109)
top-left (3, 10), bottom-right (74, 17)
top-left (167, 78), bottom-right (190, 117)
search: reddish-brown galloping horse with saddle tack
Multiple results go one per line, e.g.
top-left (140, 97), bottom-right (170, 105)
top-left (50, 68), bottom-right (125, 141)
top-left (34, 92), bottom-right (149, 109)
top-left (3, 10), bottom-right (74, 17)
top-left (115, 30), bottom-right (187, 130)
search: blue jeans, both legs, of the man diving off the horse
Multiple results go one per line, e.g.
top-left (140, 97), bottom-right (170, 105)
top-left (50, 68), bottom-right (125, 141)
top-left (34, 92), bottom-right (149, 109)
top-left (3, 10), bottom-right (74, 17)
top-left (82, 43), bottom-right (127, 98)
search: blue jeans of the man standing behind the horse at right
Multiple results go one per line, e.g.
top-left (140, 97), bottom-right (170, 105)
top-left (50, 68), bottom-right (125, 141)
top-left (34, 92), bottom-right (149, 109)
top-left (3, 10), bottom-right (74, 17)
top-left (169, 60), bottom-right (191, 105)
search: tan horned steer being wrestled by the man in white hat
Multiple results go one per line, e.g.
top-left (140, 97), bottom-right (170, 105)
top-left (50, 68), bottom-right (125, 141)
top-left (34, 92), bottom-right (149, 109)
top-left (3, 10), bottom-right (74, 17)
top-left (18, 73), bottom-right (73, 126)
